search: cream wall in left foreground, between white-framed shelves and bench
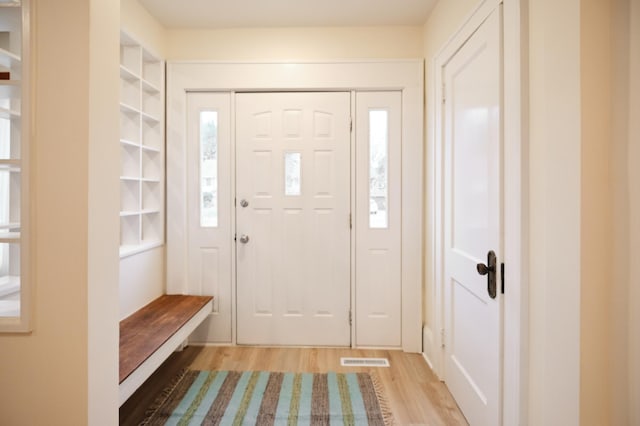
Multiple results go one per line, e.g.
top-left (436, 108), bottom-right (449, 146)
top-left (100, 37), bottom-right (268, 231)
top-left (0, 0), bottom-right (118, 426)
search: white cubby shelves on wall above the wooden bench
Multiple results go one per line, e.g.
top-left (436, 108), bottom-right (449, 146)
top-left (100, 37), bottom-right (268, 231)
top-left (120, 32), bottom-right (164, 257)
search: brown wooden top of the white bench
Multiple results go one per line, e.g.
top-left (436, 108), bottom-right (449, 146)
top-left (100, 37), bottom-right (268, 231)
top-left (120, 294), bottom-right (213, 383)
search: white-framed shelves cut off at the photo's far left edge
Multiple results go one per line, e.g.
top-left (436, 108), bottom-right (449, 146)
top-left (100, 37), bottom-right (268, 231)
top-left (0, 0), bottom-right (31, 332)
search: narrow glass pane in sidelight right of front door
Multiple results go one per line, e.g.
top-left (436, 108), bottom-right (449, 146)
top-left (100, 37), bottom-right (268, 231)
top-left (369, 110), bottom-right (389, 228)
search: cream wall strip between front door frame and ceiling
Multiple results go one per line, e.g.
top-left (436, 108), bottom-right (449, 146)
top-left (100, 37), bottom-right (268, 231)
top-left (167, 27), bottom-right (422, 62)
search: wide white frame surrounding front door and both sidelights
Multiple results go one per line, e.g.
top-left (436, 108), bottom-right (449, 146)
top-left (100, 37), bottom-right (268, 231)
top-left (166, 60), bottom-right (424, 352)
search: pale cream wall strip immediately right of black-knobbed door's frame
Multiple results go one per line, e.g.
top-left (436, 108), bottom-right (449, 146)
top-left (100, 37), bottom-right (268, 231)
top-left (529, 0), bottom-right (582, 425)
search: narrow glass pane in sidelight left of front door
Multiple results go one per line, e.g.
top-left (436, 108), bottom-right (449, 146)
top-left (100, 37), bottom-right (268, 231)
top-left (200, 111), bottom-right (218, 228)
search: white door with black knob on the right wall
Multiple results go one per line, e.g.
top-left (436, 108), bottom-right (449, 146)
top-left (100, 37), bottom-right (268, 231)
top-left (443, 8), bottom-right (502, 426)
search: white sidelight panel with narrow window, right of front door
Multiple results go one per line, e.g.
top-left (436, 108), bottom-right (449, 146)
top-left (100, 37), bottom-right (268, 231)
top-left (356, 92), bottom-right (402, 347)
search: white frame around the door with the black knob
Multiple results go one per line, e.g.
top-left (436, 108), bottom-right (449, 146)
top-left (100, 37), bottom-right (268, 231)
top-left (424, 0), bottom-right (529, 425)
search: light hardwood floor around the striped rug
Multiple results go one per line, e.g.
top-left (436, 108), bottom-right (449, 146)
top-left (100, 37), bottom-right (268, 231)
top-left (120, 346), bottom-right (467, 426)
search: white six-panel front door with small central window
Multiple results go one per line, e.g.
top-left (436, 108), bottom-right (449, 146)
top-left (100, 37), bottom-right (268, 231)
top-left (236, 93), bottom-right (350, 346)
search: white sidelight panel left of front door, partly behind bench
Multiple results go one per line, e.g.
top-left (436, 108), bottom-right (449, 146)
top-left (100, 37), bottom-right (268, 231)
top-left (186, 93), bottom-right (233, 343)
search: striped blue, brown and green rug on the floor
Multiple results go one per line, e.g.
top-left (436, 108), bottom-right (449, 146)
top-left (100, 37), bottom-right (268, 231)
top-left (141, 370), bottom-right (392, 426)
